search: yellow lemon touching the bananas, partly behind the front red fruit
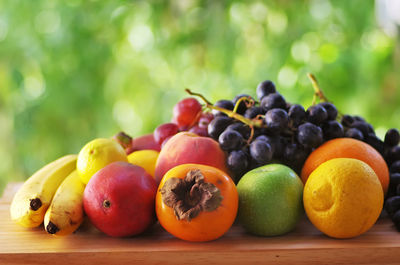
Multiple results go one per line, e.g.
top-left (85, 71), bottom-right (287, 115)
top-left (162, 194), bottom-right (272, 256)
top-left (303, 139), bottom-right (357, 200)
top-left (76, 138), bottom-right (128, 184)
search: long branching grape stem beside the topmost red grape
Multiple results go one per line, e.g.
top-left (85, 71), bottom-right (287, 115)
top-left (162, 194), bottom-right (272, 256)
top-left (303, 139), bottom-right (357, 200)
top-left (185, 88), bottom-right (265, 144)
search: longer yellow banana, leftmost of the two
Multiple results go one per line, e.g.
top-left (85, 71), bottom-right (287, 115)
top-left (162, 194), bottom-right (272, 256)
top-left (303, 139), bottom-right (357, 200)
top-left (10, 155), bottom-right (77, 227)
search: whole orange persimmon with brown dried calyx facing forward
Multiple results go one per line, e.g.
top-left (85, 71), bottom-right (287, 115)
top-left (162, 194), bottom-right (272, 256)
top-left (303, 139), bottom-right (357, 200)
top-left (156, 164), bottom-right (239, 242)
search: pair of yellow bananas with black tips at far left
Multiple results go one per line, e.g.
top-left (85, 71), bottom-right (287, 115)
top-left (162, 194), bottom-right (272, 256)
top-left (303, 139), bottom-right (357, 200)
top-left (10, 155), bottom-right (85, 235)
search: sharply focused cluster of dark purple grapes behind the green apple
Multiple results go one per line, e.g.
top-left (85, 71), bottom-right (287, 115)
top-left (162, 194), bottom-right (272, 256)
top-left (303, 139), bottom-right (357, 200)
top-left (208, 80), bottom-right (345, 181)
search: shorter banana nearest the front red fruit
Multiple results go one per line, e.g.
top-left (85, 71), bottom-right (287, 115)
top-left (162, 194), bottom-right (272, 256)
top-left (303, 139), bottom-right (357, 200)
top-left (44, 170), bottom-right (85, 236)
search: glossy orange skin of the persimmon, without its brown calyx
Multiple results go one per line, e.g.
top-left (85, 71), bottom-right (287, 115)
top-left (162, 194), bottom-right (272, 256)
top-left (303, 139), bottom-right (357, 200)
top-left (156, 164), bottom-right (238, 242)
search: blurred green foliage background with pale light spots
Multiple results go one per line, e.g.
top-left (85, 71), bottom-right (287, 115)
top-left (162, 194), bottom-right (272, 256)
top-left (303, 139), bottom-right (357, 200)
top-left (0, 0), bottom-right (400, 193)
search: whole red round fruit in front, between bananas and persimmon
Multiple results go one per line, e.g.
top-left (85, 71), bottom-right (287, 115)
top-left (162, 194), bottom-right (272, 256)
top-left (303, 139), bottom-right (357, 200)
top-left (83, 162), bottom-right (157, 237)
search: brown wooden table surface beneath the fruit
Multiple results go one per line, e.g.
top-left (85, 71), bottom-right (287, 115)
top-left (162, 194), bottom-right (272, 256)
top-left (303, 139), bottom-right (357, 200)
top-left (0, 183), bottom-right (400, 265)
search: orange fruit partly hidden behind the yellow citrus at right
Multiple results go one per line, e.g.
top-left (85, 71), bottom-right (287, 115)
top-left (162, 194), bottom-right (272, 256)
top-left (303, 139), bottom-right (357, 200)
top-left (301, 138), bottom-right (389, 194)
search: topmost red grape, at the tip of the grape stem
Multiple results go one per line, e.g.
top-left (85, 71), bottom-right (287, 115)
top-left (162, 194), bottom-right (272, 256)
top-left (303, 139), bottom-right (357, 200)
top-left (172, 98), bottom-right (201, 130)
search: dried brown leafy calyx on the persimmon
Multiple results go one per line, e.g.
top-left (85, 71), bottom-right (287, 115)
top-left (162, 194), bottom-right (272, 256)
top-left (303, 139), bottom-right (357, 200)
top-left (160, 169), bottom-right (223, 222)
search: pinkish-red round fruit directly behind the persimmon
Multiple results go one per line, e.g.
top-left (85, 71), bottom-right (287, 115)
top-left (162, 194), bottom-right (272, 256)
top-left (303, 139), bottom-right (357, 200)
top-left (155, 132), bottom-right (228, 183)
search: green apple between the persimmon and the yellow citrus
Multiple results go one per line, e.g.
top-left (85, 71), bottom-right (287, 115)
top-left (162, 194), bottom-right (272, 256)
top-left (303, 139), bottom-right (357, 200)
top-left (237, 164), bottom-right (304, 236)
